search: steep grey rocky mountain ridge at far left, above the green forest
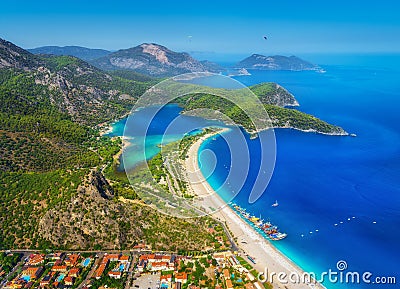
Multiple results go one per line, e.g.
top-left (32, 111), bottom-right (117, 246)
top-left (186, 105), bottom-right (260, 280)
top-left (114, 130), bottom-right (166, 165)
top-left (0, 39), bottom-right (145, 125)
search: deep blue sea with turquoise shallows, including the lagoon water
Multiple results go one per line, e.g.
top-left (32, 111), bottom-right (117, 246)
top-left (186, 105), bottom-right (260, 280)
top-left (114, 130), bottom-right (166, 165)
top-left (110, 54), bottom-right (400, 289)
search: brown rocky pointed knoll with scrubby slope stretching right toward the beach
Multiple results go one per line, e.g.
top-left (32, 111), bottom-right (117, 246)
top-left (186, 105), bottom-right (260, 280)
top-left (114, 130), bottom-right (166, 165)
top-left (38, 171), bottom-right (217, 250)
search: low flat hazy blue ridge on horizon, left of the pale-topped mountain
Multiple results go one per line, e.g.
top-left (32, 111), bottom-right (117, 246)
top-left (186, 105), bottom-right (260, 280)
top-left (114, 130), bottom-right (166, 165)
top-left (28, 46), bottom-right (111, 61)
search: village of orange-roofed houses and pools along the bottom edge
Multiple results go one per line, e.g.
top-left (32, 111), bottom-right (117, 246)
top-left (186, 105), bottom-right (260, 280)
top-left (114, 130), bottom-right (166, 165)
top-left (0, 244), bottom-right (272, 289)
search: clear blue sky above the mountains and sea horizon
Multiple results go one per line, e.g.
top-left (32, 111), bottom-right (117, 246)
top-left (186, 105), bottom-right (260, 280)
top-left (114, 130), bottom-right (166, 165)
top-left (0, 0), bottom-right (400, 55)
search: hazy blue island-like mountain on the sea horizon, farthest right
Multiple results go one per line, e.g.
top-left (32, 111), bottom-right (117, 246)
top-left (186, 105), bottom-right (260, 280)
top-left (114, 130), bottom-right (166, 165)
top-left (235, 54), bottom-right (321, 71)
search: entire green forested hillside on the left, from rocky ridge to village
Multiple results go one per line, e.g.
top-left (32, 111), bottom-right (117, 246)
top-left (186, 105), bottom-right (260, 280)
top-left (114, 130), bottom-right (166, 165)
top-left (0, 40), bottom-right (225, 250)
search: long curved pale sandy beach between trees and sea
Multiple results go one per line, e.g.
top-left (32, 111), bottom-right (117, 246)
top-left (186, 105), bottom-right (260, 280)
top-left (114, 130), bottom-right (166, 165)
top-left (185, 131), bottom-right (324, 289)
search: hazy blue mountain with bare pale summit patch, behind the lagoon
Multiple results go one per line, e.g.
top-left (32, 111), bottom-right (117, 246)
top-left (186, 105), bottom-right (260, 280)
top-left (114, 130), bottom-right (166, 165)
top-left (91, 43), bottom-right (223, 77)
